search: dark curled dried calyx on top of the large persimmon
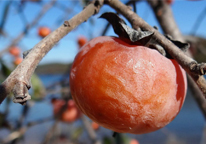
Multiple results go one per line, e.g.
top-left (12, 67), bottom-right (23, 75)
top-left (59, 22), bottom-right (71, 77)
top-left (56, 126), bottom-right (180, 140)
top-left (100, 12), bottom-right (190, 59)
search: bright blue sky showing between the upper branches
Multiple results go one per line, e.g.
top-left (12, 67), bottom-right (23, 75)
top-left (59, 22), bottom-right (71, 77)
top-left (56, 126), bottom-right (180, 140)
top-left (0, 0), bottom-right (206, 64)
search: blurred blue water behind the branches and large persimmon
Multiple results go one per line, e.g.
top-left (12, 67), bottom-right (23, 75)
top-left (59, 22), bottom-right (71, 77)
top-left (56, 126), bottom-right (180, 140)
top-left (0, 75), bottom-right (205, 144)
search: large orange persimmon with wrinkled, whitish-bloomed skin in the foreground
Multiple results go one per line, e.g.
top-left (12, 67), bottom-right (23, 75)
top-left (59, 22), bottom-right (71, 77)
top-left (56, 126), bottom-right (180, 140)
top-left (70, 36), bottom-right (187, 134)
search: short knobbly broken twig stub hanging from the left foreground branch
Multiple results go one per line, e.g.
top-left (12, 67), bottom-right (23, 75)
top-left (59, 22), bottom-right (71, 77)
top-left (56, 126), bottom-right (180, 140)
top-left (13, 81), bottom-right (31, 105)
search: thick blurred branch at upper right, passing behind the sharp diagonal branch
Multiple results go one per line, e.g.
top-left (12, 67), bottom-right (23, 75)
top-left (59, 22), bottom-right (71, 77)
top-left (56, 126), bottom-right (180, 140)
top-left (148, 0), bottom-right (206, 118)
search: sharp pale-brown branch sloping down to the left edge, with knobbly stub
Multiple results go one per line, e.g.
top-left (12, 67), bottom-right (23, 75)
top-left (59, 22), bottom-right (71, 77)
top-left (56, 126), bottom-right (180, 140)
top-left (0, 0), bottom-right (103, 104)
